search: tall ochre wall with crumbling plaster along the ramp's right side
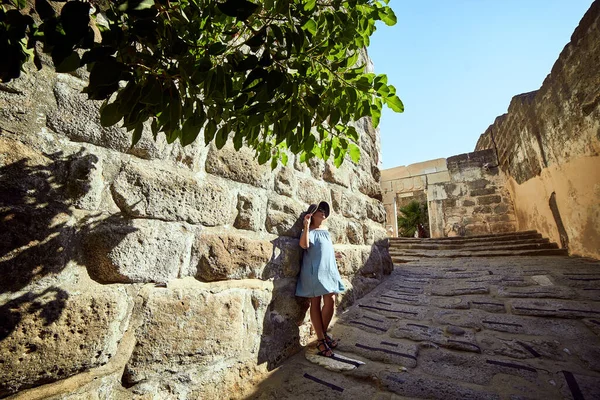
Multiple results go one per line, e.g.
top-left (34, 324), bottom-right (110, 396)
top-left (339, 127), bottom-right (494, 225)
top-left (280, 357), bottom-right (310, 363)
top-left (475, 0), bottom-right (600, 258)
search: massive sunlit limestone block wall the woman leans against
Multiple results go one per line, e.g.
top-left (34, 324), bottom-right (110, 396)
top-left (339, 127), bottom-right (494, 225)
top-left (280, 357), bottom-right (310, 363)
top-left (0, 59), bottom-right (392, 399)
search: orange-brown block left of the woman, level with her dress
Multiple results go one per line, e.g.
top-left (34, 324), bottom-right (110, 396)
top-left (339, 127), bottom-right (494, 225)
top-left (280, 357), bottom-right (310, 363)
top-left (192, 232), bottom-right (273, 282)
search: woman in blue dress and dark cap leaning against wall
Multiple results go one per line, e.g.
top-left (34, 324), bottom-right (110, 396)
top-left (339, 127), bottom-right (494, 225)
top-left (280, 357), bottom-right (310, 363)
top-left (296, 201), bottom-right (344, 357)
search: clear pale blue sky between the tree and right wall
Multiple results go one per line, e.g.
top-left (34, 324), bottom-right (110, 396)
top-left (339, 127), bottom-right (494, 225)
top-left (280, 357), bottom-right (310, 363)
top-left (368, 0), bottom-right (593, 169)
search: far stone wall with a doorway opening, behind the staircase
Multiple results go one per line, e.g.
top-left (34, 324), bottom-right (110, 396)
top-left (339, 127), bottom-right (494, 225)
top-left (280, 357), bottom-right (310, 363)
top-left (381, 150), bottom-right (516, 238)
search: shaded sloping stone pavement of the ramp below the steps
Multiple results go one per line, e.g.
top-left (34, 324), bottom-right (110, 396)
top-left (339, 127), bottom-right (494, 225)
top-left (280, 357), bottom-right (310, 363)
top-left (251, 256), bottom-right (600, 400)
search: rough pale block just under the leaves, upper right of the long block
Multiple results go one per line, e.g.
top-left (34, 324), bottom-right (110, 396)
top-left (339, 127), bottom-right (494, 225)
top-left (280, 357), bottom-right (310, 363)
top-left (206, 142), bottom-right (271, 189)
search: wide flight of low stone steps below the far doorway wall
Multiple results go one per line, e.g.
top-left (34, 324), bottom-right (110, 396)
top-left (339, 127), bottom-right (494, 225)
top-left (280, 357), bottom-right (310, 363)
top-left (390, 231), bottom-right (568, 264)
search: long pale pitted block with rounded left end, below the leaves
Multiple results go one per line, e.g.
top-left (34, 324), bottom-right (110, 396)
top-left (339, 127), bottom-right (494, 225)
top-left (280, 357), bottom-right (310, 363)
top-left (112, 162), bottom-right (235, 226)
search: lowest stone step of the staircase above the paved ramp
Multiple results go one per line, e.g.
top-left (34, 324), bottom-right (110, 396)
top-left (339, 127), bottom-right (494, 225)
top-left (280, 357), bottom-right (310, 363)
top-left (390, 249), bottom-right (568, 264)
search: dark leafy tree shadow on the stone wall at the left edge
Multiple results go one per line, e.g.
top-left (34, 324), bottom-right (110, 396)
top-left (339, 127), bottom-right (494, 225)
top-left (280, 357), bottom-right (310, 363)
top-left (0, 145), bottom-right (134, 341)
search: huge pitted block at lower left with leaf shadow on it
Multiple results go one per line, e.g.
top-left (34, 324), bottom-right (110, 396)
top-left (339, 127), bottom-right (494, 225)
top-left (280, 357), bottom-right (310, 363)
top-left (0, 281), bottom-right (128, 397)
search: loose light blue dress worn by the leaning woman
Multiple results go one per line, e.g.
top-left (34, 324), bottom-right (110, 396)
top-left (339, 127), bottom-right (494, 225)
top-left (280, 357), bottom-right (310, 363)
top-left (296, 229), bottom-right (345, 297)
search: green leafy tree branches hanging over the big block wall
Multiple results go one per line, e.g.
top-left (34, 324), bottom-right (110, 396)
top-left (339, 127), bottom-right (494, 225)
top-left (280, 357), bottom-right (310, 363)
top-left (0, 0), bottom-right (404, 167)
